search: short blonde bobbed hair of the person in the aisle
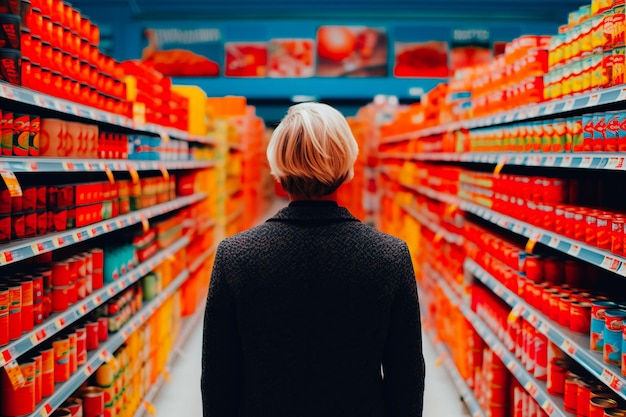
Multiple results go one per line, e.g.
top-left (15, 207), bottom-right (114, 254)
top-left (267, 103), bottom-right (359, 197)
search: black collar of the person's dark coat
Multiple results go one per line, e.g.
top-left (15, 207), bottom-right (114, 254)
top-left (267, 201), bottom-right (360, 224)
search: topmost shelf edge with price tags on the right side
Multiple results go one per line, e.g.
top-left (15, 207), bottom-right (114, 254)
top-left (381, 86), bottom-right (626, 144)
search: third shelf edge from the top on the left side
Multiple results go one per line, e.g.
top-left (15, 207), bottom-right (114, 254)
top-left (0, 193), bottom-right (206, 266)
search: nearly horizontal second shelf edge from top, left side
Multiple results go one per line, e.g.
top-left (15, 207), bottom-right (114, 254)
top-left (0, 157), bottom-right (215, 173)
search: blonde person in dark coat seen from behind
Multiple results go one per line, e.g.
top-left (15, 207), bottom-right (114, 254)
top-left (201, 103), bottom-right (425, 417)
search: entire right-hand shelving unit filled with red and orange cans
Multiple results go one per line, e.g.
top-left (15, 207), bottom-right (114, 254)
top-left (372, 1), bottom-right (626, 417)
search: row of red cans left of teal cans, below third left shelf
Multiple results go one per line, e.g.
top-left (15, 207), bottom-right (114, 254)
top-left (0, 248), bottom-right (103, 346)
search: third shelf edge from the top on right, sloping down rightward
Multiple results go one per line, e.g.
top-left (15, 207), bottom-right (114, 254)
top-left (401, 180), bottom-right (626, 277)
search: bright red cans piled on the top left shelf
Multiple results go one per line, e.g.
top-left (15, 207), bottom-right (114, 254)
top-left (18, 0), bottom-right (130, 115)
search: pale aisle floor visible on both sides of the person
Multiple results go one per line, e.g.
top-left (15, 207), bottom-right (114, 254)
top-left (154, 200), bottom-right (468, 417)
